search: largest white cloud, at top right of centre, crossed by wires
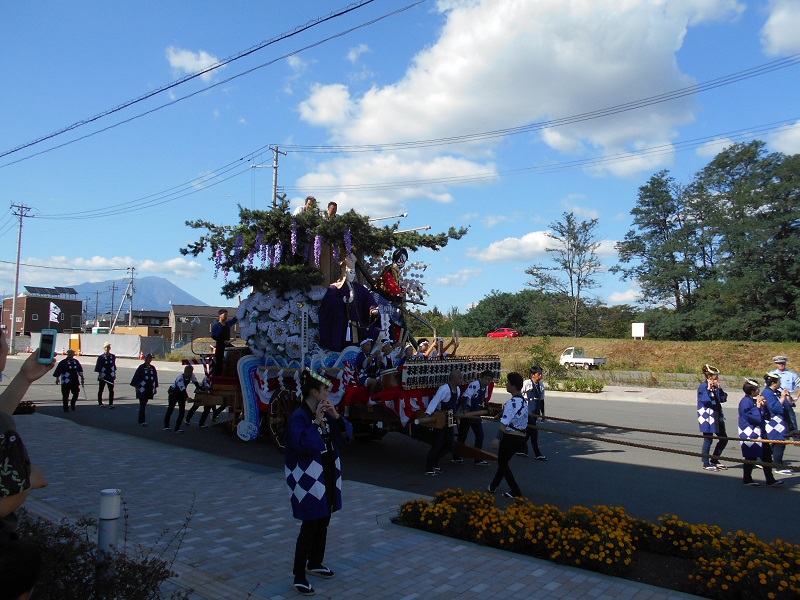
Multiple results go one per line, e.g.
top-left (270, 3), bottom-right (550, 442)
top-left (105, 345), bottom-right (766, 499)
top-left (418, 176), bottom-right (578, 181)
top-left (299, 0), bottom-right (744, 204)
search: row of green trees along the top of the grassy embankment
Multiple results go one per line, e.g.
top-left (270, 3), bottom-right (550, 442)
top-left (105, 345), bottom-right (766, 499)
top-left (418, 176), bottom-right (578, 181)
top-left (409, 141), bottom-right (800, 341)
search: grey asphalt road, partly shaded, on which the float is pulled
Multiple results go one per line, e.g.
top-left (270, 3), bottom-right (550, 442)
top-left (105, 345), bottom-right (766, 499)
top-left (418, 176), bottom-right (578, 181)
top-left (6, 357), bottom-right (800, 543)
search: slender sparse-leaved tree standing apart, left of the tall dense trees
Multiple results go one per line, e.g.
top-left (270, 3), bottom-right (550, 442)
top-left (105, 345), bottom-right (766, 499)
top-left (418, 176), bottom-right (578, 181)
top-left (525, 212), bottom-right (603, 337)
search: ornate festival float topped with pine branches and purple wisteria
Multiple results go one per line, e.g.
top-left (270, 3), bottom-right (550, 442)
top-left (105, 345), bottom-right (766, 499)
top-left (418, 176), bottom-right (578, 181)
top-left (181, 200), bottom-right (500, 458)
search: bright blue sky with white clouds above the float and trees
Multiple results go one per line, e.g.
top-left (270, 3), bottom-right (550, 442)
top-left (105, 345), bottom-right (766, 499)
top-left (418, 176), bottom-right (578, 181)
top-left (0, 0), bottom-right (800, 312)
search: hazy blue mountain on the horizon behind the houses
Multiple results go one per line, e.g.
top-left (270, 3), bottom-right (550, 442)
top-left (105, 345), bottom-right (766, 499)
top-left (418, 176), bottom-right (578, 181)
top-left (72, 277), bottom-right (208, 316)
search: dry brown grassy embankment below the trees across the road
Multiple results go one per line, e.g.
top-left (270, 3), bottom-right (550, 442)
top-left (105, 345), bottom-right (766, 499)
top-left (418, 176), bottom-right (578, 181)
top-left (458, 337), bottom-right (800, 377)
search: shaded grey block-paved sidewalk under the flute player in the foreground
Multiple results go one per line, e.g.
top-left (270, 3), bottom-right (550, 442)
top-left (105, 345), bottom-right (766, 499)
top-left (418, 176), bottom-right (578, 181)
top-left (16, 414), bottom-right (692, 600)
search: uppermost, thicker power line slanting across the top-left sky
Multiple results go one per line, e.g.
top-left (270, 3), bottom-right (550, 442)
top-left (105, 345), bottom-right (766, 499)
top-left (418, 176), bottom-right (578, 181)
top-left (0, 0), bottom-right (384, 158)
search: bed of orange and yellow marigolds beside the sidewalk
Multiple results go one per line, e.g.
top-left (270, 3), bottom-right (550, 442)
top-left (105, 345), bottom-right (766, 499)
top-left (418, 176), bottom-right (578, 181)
top-left (397, 489), bottom-right (800, 600)
